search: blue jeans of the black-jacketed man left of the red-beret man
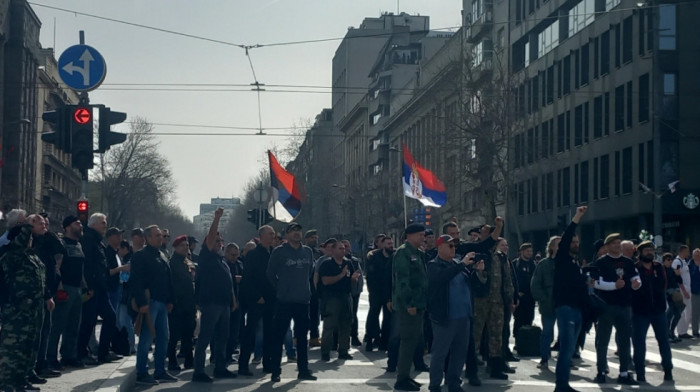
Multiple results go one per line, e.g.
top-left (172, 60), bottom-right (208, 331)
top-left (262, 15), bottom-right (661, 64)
top-left (136, 300), bottom-right (170, 374)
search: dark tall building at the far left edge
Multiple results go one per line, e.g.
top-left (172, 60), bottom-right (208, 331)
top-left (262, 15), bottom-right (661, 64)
top-left (0, 0), bottom-right (41, 211)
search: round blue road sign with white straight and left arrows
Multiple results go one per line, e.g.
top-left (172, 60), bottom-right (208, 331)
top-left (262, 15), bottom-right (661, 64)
top-left (58, 45), bottom-right (107, 91)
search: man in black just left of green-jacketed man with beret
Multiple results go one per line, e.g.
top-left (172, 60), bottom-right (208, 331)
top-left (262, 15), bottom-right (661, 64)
top-left (365, 234), bottom-right (394, 352)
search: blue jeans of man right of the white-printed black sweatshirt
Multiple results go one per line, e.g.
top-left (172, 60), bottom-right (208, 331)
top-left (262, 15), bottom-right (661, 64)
top-left (632, 313), bottom-right (673, 377)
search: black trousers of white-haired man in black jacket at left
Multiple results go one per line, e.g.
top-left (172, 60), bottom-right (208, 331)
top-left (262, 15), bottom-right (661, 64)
top-left (78, 290), bottom-right (117, 358)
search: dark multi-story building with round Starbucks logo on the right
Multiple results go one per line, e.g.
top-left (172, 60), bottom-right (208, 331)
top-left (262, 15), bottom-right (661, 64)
top-left (500, 0), bottom-right (700, 259)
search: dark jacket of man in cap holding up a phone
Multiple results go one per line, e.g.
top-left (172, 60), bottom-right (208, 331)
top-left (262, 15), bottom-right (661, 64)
top-left (428, 257), bottom-right (471, 324)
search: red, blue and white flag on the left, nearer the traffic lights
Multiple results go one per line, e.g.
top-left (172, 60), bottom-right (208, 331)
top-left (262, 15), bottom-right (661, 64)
top-left (267, 151), bottom-right (301, 223)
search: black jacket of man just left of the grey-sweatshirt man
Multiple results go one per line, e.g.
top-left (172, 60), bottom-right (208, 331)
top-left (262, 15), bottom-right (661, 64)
top-left (240, 244), bottom-right (277, 305)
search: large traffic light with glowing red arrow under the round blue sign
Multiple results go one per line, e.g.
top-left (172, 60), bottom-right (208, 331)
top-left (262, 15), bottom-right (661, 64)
top-left (66, 105), bottom-right (95, 170)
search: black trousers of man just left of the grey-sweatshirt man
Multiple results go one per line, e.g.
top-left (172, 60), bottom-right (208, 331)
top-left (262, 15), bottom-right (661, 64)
top-left (238, 303), bottom-right (274, 371)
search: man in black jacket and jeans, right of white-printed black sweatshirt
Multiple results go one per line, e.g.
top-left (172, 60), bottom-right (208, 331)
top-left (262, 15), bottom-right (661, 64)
top-left (632, 241), bottom-right (673, 383)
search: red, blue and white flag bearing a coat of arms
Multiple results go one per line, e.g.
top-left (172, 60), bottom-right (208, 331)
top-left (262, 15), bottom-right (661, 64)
top-left (403, 143), bottom-right (447, 207)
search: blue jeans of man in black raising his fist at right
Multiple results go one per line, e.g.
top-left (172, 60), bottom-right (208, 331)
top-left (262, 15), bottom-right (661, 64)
top-left (556, 306), bottom-right (583, 388)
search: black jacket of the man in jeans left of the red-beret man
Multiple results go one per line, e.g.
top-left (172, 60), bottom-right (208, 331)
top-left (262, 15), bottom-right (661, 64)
top-left (129, 245), bottom-right (174, 307)
